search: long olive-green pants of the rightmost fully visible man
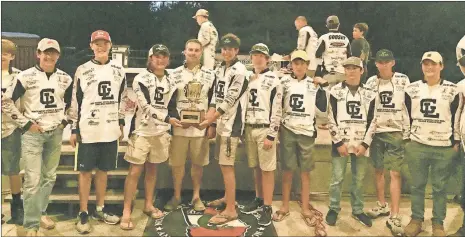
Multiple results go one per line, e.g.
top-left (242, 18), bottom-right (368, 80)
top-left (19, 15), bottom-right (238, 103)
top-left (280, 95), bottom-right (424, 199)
top-left (405, 141), bottom-right (458, 225)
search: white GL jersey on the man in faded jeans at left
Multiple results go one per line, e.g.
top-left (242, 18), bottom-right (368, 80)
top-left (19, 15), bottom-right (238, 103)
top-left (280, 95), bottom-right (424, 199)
top-left (2, 65), bottom-right (73, 131)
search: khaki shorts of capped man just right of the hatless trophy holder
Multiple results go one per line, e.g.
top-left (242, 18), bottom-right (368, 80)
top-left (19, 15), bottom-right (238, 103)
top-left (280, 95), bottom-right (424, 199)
top-left (215, 135), bottom-right (239, 166)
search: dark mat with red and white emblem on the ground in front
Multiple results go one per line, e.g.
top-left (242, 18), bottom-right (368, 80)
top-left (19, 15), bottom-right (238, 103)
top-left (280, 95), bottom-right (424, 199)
top-left (144, 189), bottom-right (277, 237)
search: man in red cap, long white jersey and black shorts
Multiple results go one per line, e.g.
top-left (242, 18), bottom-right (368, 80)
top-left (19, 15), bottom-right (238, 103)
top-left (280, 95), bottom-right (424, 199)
top-left (69, 30), bottom-right (126, 234)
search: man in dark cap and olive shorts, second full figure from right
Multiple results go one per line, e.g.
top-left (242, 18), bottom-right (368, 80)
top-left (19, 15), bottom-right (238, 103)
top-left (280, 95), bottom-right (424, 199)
top-left (364, 49), bottom-right (410, 236)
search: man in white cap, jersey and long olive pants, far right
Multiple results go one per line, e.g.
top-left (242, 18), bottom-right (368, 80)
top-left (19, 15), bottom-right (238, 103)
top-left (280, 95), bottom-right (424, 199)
top-left (404, 51), bottom-right (462, 236)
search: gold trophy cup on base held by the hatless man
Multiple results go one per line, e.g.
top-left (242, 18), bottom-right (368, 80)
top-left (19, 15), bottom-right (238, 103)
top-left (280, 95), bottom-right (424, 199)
top-left (180, 78), bottom-right (205, 126)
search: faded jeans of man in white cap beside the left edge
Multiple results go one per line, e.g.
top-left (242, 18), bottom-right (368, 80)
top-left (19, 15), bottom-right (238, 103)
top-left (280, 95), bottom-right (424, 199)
top-left (22, 128), bottom-right (63, 230)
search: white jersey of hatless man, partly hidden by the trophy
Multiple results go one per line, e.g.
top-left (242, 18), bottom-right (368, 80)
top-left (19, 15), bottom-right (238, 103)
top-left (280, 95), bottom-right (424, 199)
top-left (168, 65), bottom-right (215, 137)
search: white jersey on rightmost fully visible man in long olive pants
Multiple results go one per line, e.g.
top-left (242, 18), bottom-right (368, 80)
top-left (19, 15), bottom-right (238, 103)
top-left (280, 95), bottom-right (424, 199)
top-left (405, 79), bottom-right (462, 147)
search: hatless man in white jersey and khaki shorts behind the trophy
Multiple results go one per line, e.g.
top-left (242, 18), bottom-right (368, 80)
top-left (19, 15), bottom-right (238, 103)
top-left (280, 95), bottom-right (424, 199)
top-left (164, 39), bottom-right (215, 211)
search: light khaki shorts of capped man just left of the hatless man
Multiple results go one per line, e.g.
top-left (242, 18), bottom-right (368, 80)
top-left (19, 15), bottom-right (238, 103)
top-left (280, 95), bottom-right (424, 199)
top-left (124, 133), bottom-right (171, 165)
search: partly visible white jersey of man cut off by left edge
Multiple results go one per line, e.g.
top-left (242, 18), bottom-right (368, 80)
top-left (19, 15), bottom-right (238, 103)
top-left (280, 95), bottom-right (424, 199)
top-left (2, 67), bottom-right (21, 138)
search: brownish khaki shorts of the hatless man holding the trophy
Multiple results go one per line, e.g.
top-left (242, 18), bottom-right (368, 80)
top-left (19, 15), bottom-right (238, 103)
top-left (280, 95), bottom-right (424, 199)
top-left (169, 136), bottom-right (210, 166)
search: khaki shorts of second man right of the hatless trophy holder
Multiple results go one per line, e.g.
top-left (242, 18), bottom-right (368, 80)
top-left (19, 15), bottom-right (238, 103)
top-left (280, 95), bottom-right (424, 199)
top-left (245, 124), bottom-right (277, 171)
